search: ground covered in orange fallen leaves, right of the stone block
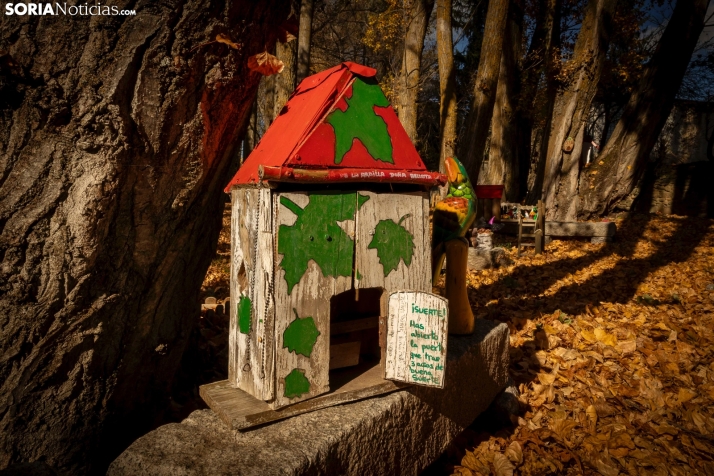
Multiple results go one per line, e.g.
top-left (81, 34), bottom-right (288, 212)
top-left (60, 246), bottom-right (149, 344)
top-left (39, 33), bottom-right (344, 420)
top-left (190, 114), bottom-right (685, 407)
top-left (444, 215), bottom-right (714, 476)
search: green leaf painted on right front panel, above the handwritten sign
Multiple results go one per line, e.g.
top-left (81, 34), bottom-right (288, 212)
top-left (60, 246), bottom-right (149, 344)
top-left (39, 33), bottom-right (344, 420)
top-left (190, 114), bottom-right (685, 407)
top-left (367, 215), bottom-right (414, 276)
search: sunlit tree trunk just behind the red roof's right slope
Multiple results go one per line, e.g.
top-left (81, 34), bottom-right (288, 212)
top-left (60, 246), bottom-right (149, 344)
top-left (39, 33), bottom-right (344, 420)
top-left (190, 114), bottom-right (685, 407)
top-left (397, 0), bottom-right (434, 143)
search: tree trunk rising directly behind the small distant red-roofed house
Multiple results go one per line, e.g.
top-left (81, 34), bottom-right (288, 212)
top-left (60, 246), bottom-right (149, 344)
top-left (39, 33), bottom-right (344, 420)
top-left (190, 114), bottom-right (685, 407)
top-left (483, 3), bottom-right (523, 202)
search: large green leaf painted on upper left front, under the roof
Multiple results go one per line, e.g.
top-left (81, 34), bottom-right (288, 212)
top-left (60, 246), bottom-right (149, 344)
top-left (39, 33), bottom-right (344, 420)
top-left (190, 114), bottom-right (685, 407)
top-left (278, 192), bottom-right (369, 294)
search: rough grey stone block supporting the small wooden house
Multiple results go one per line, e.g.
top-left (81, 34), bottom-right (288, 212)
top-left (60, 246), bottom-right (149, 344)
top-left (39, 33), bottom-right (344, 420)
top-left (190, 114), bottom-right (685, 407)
top-left (107, 319), bottom-right (509, 476)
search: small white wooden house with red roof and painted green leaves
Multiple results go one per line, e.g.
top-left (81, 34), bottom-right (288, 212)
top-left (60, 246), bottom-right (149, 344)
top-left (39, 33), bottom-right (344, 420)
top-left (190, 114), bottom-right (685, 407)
top-left (226, 63), bottom-right (445, 409)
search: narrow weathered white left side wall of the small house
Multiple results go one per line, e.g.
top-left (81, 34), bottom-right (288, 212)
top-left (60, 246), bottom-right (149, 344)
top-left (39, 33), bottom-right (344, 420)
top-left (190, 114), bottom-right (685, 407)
top-left (228, 188), bottom-right (275, 401)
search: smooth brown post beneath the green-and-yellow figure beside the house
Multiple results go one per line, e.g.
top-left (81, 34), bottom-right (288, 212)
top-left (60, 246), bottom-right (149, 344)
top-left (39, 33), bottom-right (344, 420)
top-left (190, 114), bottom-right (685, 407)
top-left (445, 239), bottom-right (474, 334)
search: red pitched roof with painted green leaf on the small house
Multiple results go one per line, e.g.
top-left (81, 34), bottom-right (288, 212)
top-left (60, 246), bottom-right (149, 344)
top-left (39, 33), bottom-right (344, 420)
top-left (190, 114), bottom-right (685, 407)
top-left (226, 62), bottom-right (445, 192)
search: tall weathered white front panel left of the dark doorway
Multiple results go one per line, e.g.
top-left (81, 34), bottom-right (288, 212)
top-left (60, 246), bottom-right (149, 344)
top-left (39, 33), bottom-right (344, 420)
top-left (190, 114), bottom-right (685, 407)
top-left (271, 192), bottom-right (356, 409)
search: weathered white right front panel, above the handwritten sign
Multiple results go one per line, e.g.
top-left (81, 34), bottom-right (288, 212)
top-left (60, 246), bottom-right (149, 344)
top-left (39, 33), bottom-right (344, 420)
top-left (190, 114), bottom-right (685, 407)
top-left (355, 191), bottom-right (431, 293)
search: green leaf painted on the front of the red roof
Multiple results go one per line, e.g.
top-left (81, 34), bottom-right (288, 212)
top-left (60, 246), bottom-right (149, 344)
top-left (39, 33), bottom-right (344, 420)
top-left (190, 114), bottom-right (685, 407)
top-left (327, 78), bottom-right (394, 164)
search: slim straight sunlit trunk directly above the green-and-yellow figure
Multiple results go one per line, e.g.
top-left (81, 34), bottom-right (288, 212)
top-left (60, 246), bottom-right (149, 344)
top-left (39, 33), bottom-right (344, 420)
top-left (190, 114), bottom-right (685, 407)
top-left (436, 0), bottom-right (457, 173)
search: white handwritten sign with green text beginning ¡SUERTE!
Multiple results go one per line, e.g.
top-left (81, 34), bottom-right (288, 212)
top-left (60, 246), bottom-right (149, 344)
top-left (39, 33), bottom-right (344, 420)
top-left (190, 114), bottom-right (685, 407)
top-left (385, 291), bottom-right (449, 388)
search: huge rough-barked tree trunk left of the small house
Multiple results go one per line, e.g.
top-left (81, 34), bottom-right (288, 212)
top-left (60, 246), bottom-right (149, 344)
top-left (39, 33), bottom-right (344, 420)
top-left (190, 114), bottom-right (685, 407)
top-left (0, 0), bottom-right (288, 474)
